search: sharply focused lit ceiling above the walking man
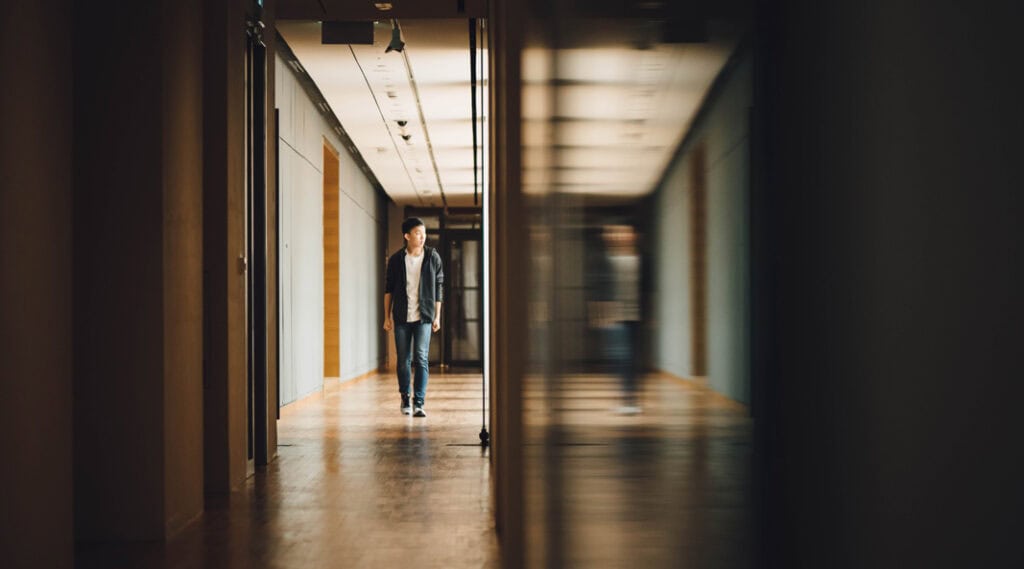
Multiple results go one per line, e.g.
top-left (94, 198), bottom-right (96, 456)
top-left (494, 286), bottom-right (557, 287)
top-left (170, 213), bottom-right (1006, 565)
top-left (278, 19), bottom-right (486, 207)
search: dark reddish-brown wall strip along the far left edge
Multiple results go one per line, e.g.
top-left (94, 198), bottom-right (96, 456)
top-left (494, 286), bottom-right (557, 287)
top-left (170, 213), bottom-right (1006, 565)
top-left (0, 0), bottom-right (73, 569)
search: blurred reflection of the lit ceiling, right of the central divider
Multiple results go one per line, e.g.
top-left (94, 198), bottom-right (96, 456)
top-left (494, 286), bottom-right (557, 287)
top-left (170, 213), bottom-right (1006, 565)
top-left (523, 18), bottom-right (740, 202)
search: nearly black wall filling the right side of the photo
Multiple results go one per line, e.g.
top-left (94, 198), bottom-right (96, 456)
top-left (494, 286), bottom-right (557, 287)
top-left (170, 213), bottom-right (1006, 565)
top-left (754, 0), bottom-right (1024, 568)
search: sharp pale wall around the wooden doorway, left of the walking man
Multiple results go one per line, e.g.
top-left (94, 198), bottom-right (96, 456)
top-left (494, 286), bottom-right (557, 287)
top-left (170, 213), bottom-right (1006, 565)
top-left (275, 51), bottom-right (387, 405)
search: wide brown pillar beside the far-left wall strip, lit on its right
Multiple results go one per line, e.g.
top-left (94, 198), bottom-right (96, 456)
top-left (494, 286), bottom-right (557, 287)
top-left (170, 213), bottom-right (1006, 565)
top-left (74, 2), bottom-right (203, 540)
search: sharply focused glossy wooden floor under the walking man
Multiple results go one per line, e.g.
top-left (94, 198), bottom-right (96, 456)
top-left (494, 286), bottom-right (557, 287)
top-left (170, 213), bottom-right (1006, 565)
top-left (76, 373), bottom-right (498, 569)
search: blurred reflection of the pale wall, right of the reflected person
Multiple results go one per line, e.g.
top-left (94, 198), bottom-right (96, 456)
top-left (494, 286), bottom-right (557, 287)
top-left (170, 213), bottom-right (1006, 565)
top-left (653, 48), bottom-right (753, 402)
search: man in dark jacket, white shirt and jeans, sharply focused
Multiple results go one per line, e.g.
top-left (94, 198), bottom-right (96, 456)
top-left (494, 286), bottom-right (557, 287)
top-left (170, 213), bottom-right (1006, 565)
top-left (384, 217), bottom-right (444, 417)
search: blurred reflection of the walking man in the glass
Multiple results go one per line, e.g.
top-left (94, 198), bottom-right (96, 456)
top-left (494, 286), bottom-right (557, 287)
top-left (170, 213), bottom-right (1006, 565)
top-left (590, 225), bottom-right (641, 414)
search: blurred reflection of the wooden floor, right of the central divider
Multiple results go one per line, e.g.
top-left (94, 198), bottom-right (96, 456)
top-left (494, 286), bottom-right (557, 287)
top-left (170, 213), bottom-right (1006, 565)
top-left (524, 375), bottom-right (755, 569)
